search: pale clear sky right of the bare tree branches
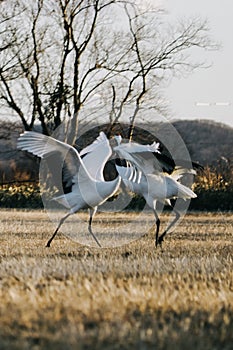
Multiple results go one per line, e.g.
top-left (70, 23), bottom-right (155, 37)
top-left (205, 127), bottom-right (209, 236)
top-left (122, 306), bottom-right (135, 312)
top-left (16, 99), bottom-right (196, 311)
top-left (159, 0), bottom-right (233, 127)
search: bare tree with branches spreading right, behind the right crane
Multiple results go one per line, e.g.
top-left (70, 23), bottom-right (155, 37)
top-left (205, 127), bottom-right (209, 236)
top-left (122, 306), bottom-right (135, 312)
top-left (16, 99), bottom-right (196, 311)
top-left (104, 4), bottom-right (218, 139)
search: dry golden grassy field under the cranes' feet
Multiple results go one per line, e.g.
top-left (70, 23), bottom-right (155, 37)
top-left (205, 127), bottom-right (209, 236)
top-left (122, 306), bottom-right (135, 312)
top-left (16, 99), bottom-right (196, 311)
top-left (0, 211), bottom-right (233, 350)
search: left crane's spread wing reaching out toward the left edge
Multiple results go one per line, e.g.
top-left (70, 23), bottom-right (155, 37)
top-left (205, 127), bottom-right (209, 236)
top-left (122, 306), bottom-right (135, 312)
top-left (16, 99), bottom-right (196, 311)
top-left (17, 131), bottom-right (91, 185)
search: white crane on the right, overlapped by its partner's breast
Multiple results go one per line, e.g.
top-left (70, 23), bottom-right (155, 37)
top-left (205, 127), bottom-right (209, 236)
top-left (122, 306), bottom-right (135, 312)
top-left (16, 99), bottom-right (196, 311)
top-left (114, 137), bottom-right (198, 247)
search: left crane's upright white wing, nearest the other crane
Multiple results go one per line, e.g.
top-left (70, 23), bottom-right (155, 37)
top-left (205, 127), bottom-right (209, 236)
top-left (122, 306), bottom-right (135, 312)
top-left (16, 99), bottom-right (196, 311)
top-left (80, 131), bottom-right (112, 181)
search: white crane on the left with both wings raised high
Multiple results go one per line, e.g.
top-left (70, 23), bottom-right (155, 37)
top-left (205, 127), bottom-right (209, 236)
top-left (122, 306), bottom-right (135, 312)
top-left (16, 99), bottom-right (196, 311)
top-left (17, 131), bottom-right (121, 247)
